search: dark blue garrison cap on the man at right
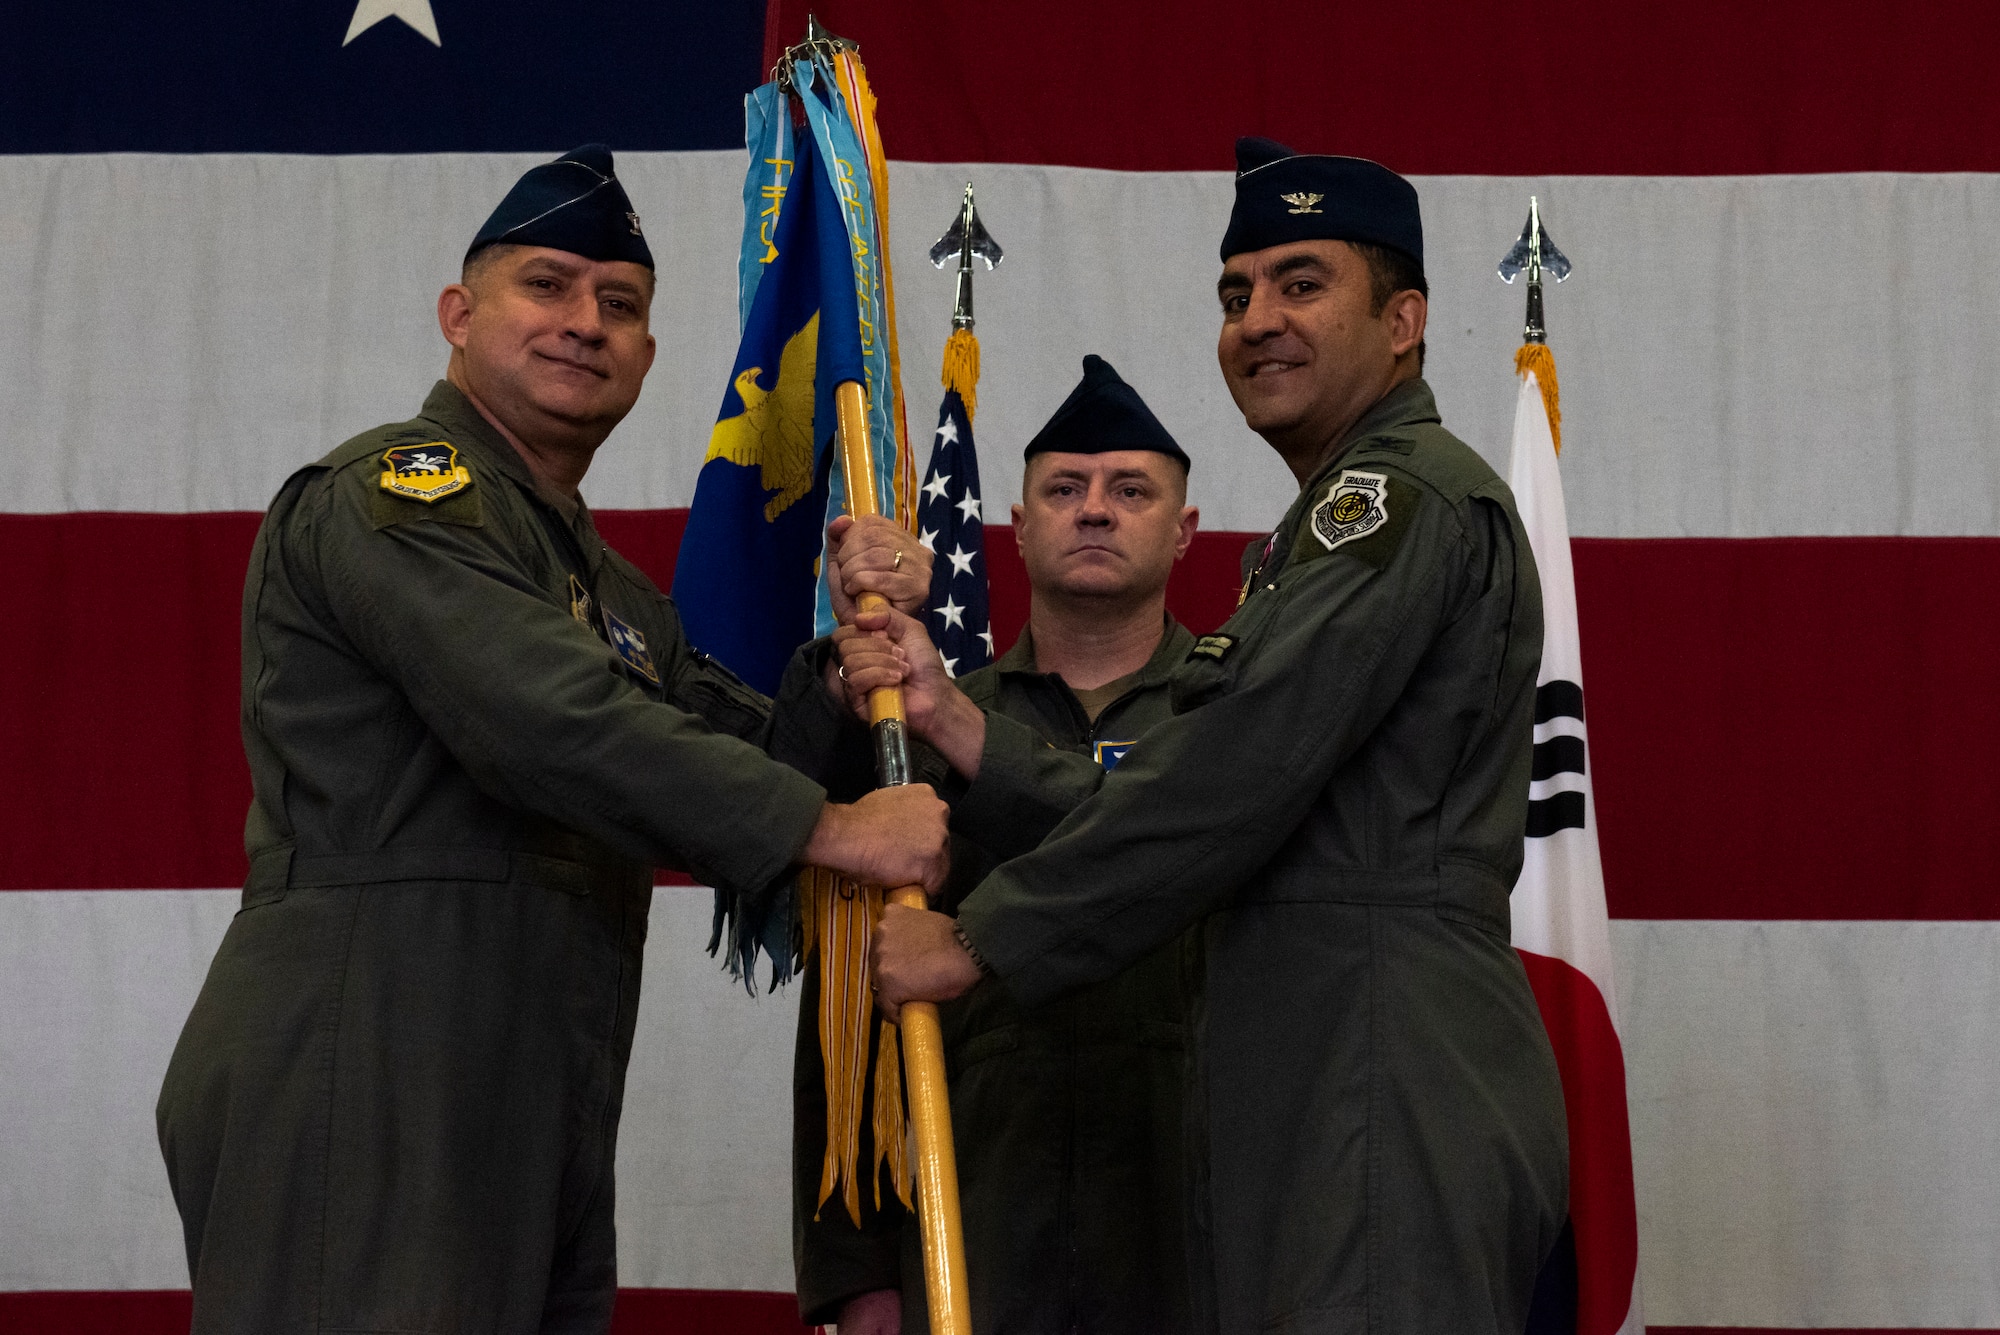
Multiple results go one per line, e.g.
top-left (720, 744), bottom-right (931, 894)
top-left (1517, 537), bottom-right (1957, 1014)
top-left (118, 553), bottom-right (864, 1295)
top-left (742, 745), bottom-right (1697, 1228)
top-left (1222, 138), bottom-right (1424, 268)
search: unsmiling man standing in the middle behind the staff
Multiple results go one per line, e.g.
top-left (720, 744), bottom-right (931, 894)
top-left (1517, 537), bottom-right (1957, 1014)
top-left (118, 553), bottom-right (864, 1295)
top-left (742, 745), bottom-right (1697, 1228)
top-left (792, 356), bottom-right (1200, 1335)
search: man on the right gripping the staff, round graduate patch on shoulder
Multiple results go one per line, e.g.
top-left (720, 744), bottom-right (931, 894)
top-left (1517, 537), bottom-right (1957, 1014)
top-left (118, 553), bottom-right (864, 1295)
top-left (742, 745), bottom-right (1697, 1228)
top-left (848, 140), bottom-right (1568, 1335)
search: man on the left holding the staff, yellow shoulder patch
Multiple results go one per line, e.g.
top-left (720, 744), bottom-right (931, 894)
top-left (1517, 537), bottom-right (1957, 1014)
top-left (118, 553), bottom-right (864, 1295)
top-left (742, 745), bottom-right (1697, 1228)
top-left (158, 144), bottom-right (946, 1335)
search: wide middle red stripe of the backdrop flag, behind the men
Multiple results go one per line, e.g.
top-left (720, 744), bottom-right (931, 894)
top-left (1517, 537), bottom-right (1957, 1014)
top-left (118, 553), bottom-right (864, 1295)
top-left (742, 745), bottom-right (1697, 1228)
top-left (0, 512), bottom-right (2000, 919)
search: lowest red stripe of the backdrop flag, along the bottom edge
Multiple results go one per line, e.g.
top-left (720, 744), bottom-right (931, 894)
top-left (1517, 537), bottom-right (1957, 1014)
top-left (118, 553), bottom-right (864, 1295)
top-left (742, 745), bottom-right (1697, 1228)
top-left (0, 1289), bottom-right (820, 1335)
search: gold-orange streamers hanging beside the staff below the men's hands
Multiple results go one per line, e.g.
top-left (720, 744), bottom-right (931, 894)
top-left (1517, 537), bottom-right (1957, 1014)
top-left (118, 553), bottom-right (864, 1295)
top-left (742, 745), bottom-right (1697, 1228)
top-left (798, 867), bottom-right (910, 1227)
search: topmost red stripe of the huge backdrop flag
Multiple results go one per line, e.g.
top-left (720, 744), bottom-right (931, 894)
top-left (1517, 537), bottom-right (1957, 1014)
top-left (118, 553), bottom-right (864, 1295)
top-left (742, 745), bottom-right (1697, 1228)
top-left (766, 0), bottom-right (2000, 174)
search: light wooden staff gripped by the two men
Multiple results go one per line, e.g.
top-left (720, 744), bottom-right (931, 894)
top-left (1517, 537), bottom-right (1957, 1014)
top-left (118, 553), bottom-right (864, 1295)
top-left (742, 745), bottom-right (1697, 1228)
top-left (834, 380), bottom-right (972, 1335)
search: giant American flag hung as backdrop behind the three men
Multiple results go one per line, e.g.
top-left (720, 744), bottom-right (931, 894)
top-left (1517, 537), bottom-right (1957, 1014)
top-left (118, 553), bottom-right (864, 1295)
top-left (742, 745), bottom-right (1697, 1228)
top-left (0, 0), bottom-right (2000, 1331)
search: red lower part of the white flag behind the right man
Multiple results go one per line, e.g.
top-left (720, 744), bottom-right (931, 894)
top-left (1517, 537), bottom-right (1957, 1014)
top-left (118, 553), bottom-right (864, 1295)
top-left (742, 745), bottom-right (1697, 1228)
top-left (1516, 951), bottom-right (1638, 1335)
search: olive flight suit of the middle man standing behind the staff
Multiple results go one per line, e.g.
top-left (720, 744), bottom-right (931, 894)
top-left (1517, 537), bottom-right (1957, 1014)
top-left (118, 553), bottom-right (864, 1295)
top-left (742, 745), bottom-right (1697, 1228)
top-left (792, 620), bottom-right (1194, 1335)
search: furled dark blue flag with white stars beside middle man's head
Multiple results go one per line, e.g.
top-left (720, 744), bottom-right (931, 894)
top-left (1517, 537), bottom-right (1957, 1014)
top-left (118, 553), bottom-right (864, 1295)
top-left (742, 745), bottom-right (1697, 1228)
top-left (916, 390), bottom-right (994, 677)
